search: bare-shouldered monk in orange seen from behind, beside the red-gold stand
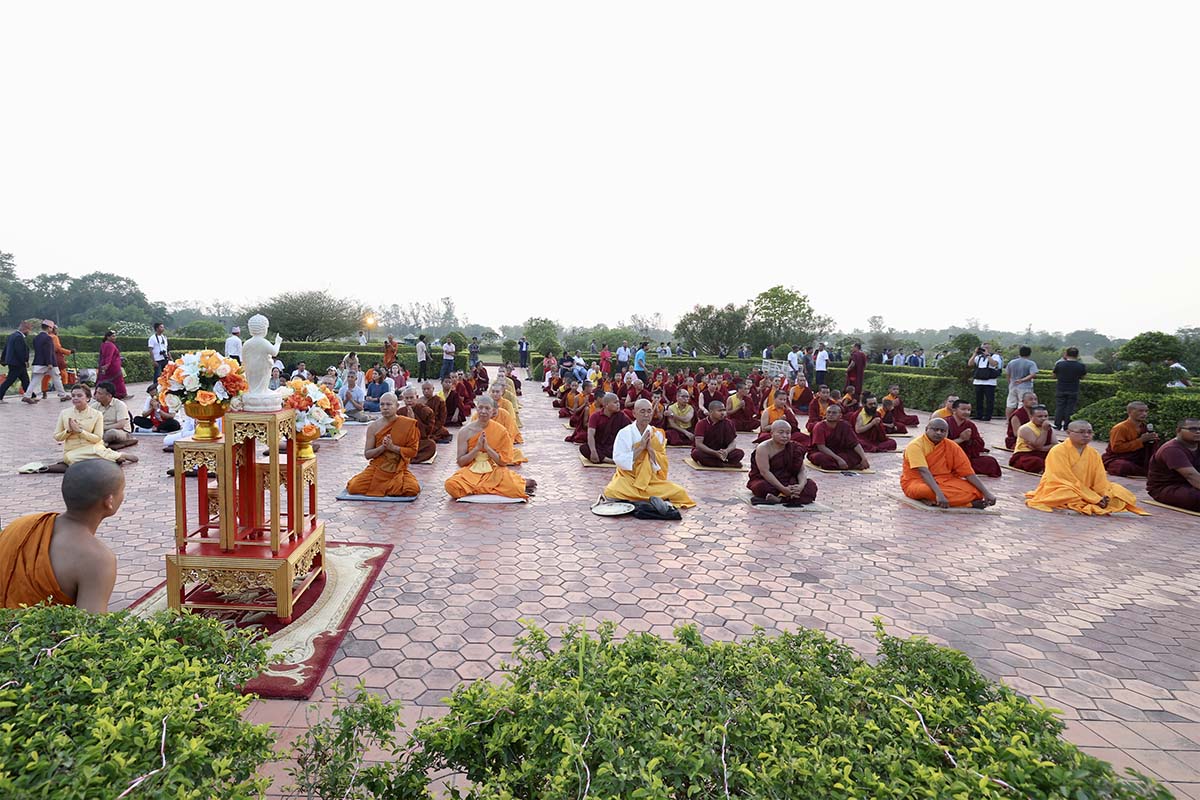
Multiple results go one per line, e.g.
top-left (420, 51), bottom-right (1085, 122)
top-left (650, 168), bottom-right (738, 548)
top-left (0, 458), bottom-right (125, 614)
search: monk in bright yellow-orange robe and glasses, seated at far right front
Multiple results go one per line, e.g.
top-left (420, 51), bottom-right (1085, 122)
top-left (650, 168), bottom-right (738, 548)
top-left (1016, 422), bottom-right (1146, 515)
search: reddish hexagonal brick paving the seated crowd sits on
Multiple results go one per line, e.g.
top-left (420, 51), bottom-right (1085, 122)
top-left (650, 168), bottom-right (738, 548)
top-left (0, 386), bottom-right (1200, 799)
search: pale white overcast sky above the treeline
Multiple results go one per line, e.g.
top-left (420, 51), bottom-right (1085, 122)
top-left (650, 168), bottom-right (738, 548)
top-left (0, 0), bottom-right (1200, 336)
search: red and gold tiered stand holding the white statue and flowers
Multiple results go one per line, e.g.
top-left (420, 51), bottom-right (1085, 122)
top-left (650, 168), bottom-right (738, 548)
top-left (167, 409), bottom-right (325, 622)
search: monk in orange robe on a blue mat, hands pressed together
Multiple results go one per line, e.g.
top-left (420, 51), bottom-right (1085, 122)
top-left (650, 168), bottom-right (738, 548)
top-left (346, 392), bottom-right (424, 498)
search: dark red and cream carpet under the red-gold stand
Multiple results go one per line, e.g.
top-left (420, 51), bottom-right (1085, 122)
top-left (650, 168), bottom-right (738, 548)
top-left (130, 542), bottom-right (392, 700)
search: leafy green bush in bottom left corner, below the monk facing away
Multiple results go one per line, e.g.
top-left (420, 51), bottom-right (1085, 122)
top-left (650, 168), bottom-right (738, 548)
top-left (0, 606), bottom-right (272, 800)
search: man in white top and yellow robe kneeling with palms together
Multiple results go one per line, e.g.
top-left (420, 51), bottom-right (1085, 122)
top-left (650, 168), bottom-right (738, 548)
top-left (604, 398), bottom-right (696, 509)
